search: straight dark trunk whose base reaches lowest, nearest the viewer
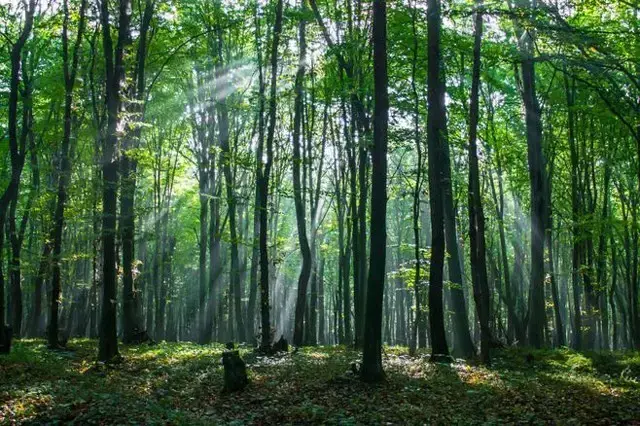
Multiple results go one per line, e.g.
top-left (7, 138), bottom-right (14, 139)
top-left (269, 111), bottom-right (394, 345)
top-left (361, 0), bottom-right (389, 382)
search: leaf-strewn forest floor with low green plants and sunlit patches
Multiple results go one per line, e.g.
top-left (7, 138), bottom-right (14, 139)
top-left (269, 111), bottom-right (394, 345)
top-left (0, 339), bottom-right (640, 425)
